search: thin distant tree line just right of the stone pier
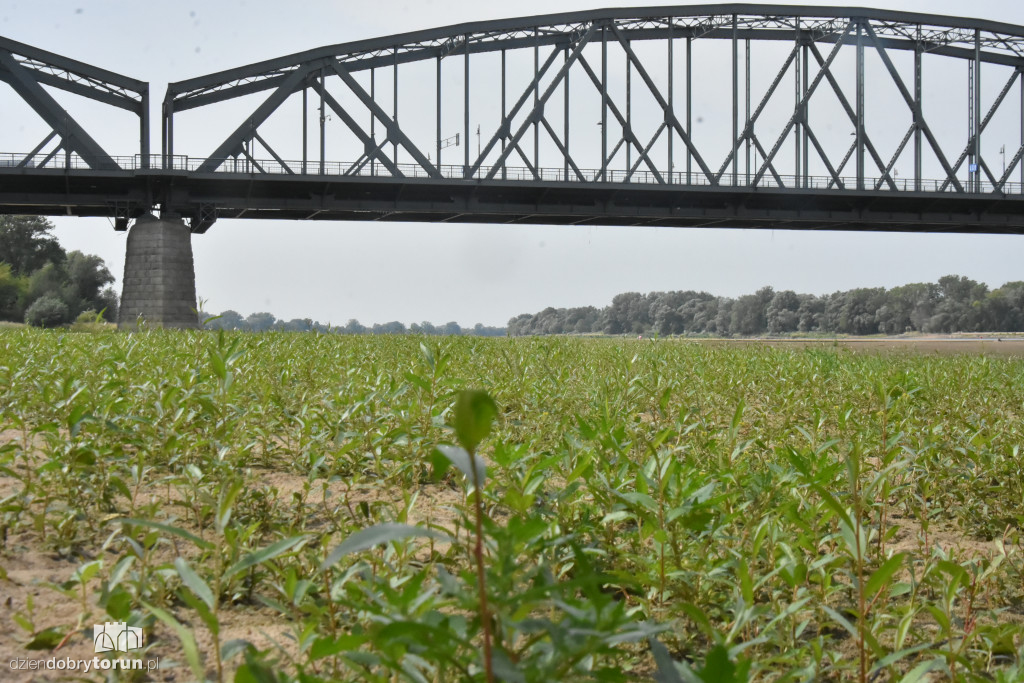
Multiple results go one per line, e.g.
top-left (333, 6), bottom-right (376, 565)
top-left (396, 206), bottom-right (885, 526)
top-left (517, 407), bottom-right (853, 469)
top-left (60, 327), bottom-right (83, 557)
top-left (203, 310), bottom-right (506, 337)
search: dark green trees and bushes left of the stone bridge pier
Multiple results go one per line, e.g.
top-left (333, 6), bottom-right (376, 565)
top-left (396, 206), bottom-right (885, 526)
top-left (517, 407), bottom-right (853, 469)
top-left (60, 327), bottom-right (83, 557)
top-left (0, 216), bottom-right (118, 327)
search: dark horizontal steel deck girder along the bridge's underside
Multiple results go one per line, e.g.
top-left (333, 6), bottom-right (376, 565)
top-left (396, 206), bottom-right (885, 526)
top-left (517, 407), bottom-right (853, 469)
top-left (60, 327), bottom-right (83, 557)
top-left (6, 169), bottom-right (1024, 234)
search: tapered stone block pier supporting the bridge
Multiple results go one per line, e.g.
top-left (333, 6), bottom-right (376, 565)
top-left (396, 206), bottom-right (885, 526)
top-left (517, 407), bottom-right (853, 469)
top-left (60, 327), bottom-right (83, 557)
top-left (118, 215), bottom-right (199, 330)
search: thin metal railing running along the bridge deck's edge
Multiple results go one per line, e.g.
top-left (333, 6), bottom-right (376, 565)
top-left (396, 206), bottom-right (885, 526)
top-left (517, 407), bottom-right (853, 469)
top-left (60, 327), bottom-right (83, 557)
top-left (0, 148), bottom-right (1024, 195)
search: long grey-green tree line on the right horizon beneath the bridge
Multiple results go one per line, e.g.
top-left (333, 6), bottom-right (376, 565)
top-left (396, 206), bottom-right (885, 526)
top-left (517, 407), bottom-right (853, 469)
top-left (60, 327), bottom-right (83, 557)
top-left (508, 275), bottom-right (1024, 337)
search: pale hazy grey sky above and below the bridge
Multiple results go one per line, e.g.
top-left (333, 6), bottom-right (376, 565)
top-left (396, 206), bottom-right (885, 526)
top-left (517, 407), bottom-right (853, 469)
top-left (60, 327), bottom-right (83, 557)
top-left (0, 0), bottom-right (1024, 326)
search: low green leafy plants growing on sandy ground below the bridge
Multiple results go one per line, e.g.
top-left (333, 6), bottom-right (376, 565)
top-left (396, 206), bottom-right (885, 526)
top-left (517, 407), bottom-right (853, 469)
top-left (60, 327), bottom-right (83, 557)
top-left (0, 329), bottom-right (1024, 683)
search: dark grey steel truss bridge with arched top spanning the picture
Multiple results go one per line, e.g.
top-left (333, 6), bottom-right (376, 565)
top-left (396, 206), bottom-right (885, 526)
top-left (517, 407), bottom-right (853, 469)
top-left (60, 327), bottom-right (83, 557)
top-left (0, 4), bottom-right (1024, 233)
